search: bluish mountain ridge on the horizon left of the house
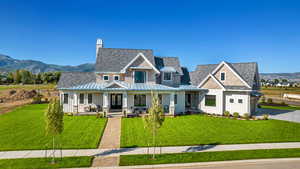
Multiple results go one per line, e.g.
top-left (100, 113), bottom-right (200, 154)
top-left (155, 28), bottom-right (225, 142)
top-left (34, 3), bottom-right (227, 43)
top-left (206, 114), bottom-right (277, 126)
top-left (0, 54), bottom-right (95, 73)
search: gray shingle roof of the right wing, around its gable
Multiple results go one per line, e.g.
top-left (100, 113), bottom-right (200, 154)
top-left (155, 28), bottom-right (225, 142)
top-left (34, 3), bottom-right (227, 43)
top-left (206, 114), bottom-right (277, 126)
top-left (190, 62), bottom-right (258, 89)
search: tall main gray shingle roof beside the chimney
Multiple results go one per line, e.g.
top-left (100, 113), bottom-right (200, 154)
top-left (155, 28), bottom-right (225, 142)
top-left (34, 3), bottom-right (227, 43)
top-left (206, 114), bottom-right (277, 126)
top-left (95, 48), bottom-right (155, 72)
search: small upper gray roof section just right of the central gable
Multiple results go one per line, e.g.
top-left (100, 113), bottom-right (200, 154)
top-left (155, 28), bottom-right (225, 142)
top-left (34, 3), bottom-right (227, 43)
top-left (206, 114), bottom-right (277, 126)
top-left (155, 56), bottom-right (183, 75)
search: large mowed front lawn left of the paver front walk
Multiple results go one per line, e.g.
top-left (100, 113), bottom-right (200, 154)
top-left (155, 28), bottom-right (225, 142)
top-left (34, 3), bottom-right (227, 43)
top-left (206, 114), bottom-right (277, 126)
top-left (0, 104), bottom-right (106, 151)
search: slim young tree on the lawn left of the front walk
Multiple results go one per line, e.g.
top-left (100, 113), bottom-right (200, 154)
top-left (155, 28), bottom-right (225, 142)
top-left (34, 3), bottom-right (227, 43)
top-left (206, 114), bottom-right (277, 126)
top-left (45, 98), bottom-right (64, 163)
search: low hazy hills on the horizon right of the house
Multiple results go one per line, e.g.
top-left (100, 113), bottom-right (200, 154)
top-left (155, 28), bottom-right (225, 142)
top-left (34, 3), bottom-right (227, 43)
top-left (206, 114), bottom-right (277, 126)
top-left (260, 72), bottom-right (300, 82)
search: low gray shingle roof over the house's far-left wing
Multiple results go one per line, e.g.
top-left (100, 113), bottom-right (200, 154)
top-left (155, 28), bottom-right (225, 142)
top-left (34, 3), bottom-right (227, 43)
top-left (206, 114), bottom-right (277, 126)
top-left (57, 72), bottom-right (96, 88)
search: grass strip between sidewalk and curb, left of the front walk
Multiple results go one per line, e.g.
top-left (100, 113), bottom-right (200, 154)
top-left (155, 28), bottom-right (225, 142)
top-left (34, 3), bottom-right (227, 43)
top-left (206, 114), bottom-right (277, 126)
top-left (0, 157), bottom-right (93, 169)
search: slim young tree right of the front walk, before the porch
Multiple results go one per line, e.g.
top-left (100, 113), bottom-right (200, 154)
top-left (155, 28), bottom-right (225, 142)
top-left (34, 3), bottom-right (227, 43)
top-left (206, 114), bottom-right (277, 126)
top-left (143, 94), bottom-right (165, 159)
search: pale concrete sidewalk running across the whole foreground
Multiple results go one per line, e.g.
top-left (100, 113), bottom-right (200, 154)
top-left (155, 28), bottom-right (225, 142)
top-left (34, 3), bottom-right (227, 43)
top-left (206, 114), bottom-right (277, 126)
top-left (0, 142), bottom-right (300, 159)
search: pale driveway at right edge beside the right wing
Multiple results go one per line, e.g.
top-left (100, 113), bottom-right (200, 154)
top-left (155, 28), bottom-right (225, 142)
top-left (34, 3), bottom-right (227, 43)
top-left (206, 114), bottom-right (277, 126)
top-left (256, 109), bottom-right (300, 123)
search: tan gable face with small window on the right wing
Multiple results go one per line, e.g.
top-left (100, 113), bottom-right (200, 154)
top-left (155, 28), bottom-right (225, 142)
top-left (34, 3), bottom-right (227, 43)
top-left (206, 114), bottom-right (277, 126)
top-left (213, 64), bottom-right (246, 86)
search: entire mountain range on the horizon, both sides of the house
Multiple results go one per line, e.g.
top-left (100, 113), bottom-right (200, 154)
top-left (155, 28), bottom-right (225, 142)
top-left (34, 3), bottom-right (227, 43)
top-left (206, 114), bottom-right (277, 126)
top-left (0, 54), bottom-right (300, 82)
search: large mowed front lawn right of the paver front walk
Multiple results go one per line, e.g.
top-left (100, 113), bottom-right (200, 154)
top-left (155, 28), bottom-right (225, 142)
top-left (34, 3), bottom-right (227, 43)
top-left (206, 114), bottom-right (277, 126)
top-left (121, 115), bottom-right (300, 147)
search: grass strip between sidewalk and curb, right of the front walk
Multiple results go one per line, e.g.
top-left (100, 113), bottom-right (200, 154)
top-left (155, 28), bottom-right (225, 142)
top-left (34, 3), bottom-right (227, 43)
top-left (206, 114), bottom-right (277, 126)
top-left (120, 149), bottom-right (300, 166)
